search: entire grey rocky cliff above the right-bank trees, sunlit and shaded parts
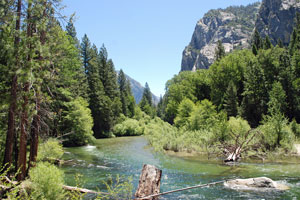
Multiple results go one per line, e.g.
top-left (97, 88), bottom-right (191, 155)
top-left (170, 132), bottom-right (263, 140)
top-left (181, 0), bottom-right (300, 71)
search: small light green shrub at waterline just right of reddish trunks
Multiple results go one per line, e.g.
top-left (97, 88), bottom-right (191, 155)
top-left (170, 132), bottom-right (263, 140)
top-left (37, 138), bottom-right (64, 161)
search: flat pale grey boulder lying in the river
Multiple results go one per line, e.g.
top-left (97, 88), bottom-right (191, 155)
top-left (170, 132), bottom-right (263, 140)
top-left (224, 177), bottom-right (289, 192)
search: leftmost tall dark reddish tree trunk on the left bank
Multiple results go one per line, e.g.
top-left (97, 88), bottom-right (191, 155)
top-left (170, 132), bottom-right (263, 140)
top-left (3, 0), bottom-right (22, 172)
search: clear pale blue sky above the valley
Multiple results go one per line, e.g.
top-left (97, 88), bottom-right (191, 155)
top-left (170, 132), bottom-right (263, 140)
top-left (63, 0), bottom-right (258, 96)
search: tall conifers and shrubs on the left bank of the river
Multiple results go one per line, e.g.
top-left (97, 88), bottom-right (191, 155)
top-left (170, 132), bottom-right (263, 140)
top-left (0, 0), bottom-right (144, 199)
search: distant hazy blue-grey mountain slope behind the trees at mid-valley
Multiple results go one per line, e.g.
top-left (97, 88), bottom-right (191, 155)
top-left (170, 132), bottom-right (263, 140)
top-left (117, 71), bottom-right (159, 105)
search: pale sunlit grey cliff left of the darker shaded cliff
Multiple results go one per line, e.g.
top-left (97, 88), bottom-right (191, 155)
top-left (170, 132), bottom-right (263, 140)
top-left (181, 3), bottom-right (260, 71)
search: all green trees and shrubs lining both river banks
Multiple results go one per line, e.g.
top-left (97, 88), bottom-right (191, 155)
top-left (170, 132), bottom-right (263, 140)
top-left (0, 0), bottom-right (300, 199)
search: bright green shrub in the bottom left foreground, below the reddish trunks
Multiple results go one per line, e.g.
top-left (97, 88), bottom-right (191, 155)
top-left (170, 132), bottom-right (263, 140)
top-left (29, 162), bottom-right (65, 200)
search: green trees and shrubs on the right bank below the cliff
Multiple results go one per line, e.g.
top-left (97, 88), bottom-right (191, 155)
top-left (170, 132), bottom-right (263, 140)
top-left (145, 21), bottom-right (300, 157)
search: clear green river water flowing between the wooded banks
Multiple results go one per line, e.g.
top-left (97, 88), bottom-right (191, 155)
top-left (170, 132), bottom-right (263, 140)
top-left (62, 137), bottom-right (300, 200)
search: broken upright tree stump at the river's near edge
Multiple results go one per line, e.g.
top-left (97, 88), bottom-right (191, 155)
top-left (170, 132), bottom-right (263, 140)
top-left (135, 164), bottom-right (162, 200)
